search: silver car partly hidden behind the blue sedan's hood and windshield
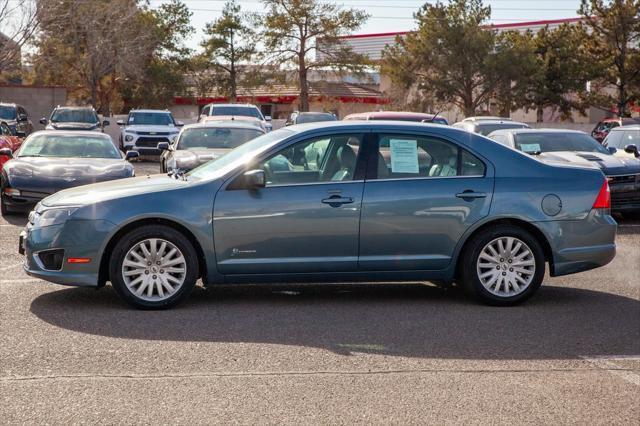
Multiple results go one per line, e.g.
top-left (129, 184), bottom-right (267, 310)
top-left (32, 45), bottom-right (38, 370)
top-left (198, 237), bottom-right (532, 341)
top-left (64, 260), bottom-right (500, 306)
top-left (158, 121), bottom-right (265, 173)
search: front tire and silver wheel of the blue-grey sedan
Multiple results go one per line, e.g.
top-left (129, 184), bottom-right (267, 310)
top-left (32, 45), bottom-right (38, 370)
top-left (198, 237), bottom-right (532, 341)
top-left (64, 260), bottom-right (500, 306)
top-left (109, 225), bottom-right (199, 309)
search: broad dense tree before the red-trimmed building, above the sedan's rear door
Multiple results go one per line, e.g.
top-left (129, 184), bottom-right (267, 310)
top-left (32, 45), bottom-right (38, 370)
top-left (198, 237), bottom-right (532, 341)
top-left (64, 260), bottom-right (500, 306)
top-left (381, 0), bottom-right (499, 115)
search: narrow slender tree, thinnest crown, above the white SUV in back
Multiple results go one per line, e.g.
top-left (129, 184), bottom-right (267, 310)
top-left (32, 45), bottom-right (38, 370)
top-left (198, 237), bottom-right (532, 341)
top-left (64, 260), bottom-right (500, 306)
top-left (202, 0), bottom-right (257, 102)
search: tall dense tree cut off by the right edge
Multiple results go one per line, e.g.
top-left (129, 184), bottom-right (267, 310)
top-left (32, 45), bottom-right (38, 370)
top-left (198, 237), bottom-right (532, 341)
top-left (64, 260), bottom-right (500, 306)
top-left (579, 0), bottom-right (640, 117)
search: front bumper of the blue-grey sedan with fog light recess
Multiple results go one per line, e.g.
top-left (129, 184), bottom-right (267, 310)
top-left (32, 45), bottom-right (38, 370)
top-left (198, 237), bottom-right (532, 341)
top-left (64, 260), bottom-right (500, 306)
top-left (18, 220), bottom-right (115, 287)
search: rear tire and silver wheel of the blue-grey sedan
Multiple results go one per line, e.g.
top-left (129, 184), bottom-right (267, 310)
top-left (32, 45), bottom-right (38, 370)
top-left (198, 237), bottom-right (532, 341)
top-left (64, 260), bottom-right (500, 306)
top-left (462, 225), bottom-right (545, 306)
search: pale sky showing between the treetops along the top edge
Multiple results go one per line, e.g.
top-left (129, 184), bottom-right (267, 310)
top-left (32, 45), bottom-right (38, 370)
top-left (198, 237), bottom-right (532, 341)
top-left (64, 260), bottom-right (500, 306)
top-left (151, 0), bottom-right (580, 48)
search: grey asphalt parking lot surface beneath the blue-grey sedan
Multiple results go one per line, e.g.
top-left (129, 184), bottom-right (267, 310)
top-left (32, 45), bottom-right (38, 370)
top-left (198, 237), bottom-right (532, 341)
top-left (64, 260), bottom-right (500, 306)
top-left (0, 162), bottom-right (640, 424)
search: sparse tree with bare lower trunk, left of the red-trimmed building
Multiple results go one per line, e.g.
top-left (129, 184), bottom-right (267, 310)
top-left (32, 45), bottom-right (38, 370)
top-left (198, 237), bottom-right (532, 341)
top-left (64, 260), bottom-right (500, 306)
top-left (262, 0), bottom-right (368, 111)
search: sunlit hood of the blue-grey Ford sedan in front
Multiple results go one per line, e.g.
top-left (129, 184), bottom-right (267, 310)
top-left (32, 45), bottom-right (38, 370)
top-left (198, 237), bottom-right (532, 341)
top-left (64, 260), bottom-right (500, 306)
top-left (42, 174), bottom-right (191, 207)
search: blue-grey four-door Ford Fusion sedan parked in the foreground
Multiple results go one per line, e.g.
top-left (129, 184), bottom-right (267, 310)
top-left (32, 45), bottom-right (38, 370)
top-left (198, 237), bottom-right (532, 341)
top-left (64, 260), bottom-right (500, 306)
top-left (19, 121), bottom-right (617, 309)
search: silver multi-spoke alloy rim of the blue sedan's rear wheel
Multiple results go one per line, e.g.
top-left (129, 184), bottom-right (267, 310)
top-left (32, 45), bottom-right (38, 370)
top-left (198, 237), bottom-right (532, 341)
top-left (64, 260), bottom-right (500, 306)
top-left (476, 237), bottom-right (536, 297)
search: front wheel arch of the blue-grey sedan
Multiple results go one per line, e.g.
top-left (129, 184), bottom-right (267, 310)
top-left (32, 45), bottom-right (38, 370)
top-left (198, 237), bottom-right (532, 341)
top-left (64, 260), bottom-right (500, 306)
top-left (98, 218), bottom-right (207, 287)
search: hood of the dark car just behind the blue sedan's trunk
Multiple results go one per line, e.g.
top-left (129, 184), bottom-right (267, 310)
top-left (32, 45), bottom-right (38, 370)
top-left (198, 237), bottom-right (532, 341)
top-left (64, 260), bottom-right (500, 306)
top-left (537, 151), bottom-right (640, 175)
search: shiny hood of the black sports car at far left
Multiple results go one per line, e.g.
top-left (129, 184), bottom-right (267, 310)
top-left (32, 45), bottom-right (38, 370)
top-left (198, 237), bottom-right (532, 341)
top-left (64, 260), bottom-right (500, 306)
top-left (4, 157), bottom-right (133, 194)
